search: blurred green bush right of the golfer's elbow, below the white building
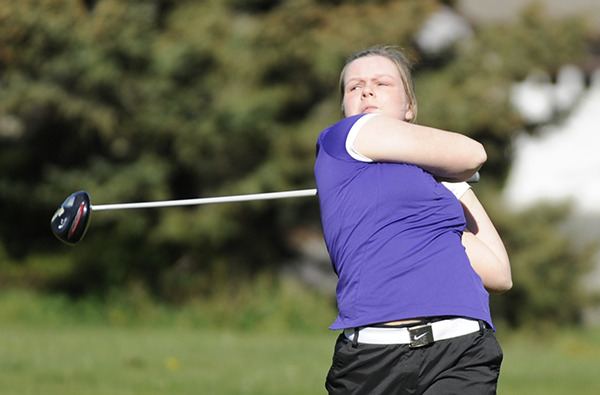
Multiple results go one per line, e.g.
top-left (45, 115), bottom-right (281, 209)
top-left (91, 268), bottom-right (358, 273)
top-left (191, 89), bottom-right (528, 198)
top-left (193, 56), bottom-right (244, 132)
top-left (492, 204), bottom-right (596, 328)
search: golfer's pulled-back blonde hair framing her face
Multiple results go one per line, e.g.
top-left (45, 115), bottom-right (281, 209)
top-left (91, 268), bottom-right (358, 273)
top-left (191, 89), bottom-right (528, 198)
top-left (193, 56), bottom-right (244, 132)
top-left (339, 45), bottom-right (417, 122)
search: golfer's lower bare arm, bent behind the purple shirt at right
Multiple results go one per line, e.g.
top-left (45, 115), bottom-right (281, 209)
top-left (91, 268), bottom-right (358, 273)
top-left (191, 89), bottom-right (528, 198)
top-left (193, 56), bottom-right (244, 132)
top-left (460, 190), bottom-right (512, 293)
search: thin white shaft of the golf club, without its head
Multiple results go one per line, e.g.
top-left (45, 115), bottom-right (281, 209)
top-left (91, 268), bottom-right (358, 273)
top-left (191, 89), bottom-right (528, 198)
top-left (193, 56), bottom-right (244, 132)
top-left (91, 189), bottom-right (317, 211)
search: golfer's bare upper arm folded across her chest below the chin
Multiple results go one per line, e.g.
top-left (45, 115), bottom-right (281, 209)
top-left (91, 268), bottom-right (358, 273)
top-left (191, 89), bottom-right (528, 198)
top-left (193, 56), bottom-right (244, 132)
top-left (354, 115), bottom-right (487, 181)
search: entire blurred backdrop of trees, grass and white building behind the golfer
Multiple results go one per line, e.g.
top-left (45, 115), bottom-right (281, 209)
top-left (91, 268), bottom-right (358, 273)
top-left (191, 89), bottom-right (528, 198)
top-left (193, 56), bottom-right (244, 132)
top-left (0, 0), bottom-right (600, 394)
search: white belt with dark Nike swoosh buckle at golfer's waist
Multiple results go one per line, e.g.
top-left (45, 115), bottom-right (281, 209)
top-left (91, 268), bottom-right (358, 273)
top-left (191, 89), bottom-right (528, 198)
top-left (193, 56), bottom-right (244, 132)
top-left (344, 318), bottom-right (481, 348)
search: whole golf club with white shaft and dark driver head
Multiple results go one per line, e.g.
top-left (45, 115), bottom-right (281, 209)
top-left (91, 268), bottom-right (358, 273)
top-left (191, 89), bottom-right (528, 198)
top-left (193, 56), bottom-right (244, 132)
top-left (50, 172), bottom-right (479, 245)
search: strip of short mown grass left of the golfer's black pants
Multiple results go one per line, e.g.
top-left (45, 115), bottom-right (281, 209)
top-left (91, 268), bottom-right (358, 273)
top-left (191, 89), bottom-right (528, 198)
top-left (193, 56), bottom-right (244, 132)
top-left (0, 327), bottom-right (334, 395)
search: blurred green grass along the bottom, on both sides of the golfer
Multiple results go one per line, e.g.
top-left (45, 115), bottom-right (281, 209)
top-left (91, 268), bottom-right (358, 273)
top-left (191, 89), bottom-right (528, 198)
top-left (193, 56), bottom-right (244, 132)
top-left (0, 292), bottom-right (600, 395)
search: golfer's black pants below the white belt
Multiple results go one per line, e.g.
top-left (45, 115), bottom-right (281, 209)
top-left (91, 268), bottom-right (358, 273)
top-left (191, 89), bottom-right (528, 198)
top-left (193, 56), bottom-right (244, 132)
top-left (325, 329), bottom-right (503, 395)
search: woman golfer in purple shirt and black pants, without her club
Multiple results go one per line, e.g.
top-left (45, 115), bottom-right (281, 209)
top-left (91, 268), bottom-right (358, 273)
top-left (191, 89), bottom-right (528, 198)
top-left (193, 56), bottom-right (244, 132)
top-left (315, 46), bottom-right (512, 395)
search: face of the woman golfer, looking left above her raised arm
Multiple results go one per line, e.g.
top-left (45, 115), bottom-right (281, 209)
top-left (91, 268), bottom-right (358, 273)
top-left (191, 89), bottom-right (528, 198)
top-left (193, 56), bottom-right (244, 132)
top-left (342, 55), bottom-right (413, 121)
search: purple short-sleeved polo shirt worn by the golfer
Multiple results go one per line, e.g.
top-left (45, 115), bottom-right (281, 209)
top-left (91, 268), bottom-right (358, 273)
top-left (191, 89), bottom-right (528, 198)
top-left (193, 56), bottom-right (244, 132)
top-left (315, 115), bottom-right (492, 329)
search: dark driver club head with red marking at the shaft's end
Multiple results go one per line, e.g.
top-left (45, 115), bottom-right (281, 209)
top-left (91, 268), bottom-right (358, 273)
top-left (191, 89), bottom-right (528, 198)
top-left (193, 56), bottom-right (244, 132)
top-left (50, 191), bottom-right (92, 245)
